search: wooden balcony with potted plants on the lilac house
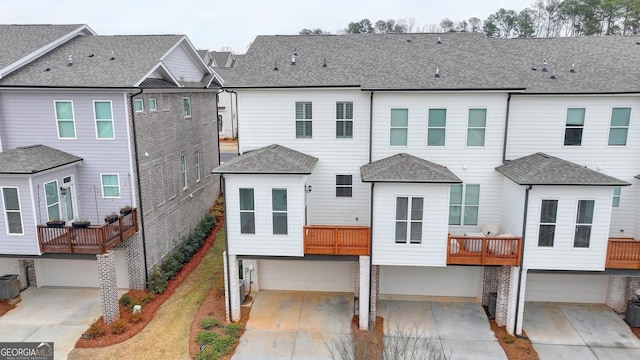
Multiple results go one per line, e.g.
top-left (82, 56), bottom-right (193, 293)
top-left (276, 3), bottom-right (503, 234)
top-left (38, 209), bottom-right (138, 254)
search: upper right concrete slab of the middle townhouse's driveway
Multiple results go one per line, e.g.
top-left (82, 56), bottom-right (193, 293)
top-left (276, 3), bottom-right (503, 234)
top-left (431, 301), bottom-right (497, 340)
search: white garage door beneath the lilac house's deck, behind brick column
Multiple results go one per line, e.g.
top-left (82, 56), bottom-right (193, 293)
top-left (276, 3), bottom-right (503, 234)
top-left (35, 250), bottom-right (129, 289)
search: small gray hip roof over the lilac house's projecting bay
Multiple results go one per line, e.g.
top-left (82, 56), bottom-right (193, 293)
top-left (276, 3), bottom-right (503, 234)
top-left (0, 145), bottom-right (82, 174)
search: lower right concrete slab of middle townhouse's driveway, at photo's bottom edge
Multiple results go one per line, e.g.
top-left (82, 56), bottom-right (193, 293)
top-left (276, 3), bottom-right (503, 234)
top-left (442, 339), bottom-right (507, 360)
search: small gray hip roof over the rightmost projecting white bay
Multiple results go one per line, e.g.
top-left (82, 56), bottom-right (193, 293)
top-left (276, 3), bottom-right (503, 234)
top-left (496, 153), bottom-right (631, 186)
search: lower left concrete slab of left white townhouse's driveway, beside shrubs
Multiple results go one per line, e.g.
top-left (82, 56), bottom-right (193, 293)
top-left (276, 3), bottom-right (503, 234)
top-left (231, 329), bottom-right (296, 360)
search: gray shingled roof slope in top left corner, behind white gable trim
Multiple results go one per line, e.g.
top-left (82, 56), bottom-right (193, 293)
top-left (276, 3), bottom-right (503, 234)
top-left (0, 24), bottom-right (83, 74)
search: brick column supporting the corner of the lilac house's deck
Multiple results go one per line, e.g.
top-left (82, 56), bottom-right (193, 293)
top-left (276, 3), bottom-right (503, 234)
top-left (96, 250), bottom-right (120, 324)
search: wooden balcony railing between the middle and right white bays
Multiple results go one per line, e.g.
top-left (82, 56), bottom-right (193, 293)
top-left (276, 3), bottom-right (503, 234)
top-left (447, 234), bottom-right (522, 265)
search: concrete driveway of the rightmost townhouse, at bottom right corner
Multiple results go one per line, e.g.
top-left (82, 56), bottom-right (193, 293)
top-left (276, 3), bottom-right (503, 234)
top-left (523, 302), bottom-right (640, 360)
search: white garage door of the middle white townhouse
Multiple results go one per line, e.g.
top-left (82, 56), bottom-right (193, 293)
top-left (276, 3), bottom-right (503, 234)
top-left (380, 266), bottom-right (483, 298)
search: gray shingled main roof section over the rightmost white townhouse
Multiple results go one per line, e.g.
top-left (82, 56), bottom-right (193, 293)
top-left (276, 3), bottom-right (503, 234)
top-left (490, 36), bottom-right (640, 93)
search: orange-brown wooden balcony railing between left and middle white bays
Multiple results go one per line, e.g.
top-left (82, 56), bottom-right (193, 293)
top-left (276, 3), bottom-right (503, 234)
top-left (304, 225), bottom-right (371, 255)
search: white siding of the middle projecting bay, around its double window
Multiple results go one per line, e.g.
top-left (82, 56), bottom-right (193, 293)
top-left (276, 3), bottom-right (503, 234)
top-left (372, 183), bottom-right (449, 266)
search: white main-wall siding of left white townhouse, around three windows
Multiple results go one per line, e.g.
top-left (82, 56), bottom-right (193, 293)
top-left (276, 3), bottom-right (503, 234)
top-left (238, 89), bottom-right (369, 226)
